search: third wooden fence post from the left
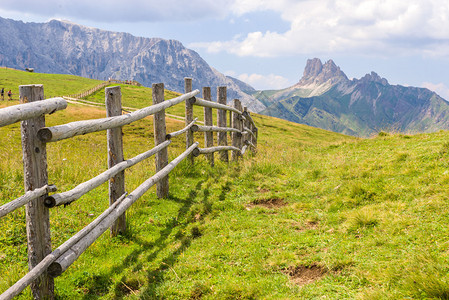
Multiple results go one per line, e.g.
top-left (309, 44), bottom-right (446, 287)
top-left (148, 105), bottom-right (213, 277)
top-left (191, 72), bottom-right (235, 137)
top-left (153, 83), bottom-right (169, 198)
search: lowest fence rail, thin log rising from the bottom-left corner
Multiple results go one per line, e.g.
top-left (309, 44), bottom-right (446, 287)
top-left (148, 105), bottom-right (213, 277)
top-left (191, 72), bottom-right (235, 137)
top-left (0, 194), bottom-right (126, 300)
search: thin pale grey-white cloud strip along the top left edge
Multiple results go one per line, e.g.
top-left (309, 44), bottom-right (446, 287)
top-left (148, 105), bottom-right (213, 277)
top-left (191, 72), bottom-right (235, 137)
top-left (1, 0), bottom-right (234, 23)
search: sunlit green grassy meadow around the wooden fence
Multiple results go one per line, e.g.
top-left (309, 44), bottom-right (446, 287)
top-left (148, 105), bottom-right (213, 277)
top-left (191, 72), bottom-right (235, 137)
top-left (0, 69), bottom-right (449, 299)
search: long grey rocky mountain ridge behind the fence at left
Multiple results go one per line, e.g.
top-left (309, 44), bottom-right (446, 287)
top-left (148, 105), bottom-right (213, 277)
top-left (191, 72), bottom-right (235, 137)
top-left (0, 17), bottom-right (265, 112)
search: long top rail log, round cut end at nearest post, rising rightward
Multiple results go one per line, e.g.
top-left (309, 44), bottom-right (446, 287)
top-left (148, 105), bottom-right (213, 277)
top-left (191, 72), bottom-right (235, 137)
top-left (38, 90), bottom-right (199, 142)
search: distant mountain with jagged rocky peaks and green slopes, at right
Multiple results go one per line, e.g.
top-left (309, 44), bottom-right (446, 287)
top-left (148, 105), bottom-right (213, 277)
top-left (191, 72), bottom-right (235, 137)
top-left (253, 58), bottom-right (449, 137)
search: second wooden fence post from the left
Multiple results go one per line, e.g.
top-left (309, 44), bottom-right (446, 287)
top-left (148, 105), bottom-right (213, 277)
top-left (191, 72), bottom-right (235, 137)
top-left (105, 86), bottom-right (126, 236)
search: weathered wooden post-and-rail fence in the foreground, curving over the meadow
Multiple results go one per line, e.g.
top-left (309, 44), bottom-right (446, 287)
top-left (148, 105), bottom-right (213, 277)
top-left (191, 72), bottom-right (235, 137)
top-left (0, 78), bottom-right (258, 300)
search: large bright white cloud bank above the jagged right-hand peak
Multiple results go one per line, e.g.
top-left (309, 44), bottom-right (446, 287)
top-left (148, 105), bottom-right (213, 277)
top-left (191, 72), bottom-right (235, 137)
top-left (194, 0), bottom-right (449, 57)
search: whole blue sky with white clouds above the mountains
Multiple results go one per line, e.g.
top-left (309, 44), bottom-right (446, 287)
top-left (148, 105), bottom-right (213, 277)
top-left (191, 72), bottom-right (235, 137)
top-left (0, 0), bottom-right (449, 100)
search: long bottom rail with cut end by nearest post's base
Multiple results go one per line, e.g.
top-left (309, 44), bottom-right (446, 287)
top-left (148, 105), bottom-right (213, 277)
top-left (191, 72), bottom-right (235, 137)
top-left (48, 143), bottom-right (198, 277)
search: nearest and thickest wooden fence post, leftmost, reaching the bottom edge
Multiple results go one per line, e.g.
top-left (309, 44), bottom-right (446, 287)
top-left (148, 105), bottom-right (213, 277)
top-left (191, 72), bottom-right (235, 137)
top-left (19, 85), bottom-right (55, 299)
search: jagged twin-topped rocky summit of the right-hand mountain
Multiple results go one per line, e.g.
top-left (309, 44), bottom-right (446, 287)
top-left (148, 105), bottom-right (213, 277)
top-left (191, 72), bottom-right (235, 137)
top-left (298, 58), bottom-right (348, 85)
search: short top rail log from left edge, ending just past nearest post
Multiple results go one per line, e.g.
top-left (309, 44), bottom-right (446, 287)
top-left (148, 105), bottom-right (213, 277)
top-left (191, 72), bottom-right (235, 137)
top-left (0, 98), bottom-right (67, 127)
